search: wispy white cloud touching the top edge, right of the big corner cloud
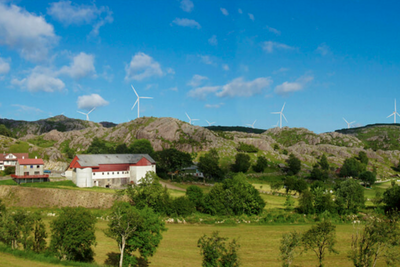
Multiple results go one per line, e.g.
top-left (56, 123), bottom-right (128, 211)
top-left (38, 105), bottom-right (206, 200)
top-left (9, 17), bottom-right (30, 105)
top-left (47, 1), bottom-right (114, 36)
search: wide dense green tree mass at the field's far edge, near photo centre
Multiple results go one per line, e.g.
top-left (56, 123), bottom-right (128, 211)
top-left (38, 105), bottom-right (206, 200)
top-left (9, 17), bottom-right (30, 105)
top-left (204, 173), bottom-right (265, 215)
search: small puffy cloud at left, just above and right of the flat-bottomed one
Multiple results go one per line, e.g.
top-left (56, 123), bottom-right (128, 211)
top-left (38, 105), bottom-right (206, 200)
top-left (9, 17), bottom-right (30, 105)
top-left (59, 52), bottom-right (96, 79)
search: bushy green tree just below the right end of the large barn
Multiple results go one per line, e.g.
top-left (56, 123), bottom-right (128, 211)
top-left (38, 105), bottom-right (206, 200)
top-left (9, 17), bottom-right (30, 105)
top-left (125, 172), bottom-right (171, 214)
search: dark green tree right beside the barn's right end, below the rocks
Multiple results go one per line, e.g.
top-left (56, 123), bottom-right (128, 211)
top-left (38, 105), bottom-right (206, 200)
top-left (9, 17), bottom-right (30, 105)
top-left (154, 148), bottom-right (193, 177)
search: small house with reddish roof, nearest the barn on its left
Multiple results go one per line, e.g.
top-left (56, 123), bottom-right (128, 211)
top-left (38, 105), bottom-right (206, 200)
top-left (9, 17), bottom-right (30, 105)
top-left (11, 158), bottom-right (50, 184)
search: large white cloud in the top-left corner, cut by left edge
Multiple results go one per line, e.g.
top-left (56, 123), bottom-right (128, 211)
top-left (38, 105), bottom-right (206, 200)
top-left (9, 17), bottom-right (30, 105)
top-left (0, 2), bottom-right (58, 61)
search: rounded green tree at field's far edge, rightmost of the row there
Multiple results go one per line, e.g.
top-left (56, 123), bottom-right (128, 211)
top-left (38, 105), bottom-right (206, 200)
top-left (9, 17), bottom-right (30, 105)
top-left (335, 179), bottom-right (365, 213)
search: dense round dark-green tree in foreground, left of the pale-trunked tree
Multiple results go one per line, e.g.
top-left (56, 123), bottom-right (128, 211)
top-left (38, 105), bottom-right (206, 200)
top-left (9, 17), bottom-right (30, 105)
top-left (50, 207), bottom-right (96, 262)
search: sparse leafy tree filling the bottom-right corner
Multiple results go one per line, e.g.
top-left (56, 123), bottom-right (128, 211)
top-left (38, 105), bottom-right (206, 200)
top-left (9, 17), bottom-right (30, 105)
top-left (348, 218), bottom-right (400, 267)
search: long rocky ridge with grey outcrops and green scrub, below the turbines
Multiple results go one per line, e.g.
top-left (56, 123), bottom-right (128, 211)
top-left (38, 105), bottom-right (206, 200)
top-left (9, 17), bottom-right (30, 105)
top-left (0, 116), bottom-right (400, 180)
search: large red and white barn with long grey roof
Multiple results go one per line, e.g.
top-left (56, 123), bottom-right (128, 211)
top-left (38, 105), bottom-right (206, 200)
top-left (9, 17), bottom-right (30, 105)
top-left (65, 154), bottom-right (156, 188)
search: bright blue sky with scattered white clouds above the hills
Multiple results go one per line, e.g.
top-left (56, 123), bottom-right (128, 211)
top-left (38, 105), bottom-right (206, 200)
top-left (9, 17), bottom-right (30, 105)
top-left (0, 0), bottom-right (400, 133)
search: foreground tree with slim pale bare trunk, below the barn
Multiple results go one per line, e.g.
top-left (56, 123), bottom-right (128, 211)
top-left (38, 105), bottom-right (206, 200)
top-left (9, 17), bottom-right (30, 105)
top-left (105, 202), bottom-right (143, 267)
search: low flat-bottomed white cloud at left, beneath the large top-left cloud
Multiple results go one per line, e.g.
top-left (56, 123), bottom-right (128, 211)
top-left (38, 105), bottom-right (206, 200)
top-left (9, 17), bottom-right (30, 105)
top-left (11, 67), bottom-right (65, 93)
